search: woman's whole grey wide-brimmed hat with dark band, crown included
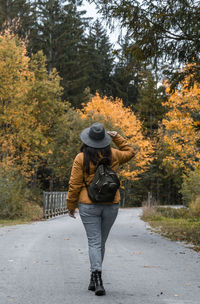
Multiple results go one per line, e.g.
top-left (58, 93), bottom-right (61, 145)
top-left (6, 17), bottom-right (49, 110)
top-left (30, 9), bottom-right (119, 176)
top-left (80, 122), bottom-right (111, 148)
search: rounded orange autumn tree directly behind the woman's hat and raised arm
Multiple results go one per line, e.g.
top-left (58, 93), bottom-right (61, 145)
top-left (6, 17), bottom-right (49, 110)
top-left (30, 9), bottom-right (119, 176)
top-left (80, 94), bottom-right (153, 180)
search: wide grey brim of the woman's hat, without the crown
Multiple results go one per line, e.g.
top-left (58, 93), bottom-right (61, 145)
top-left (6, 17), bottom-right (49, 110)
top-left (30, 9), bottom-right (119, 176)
top-left (80, 128), bottom-right (111, 148)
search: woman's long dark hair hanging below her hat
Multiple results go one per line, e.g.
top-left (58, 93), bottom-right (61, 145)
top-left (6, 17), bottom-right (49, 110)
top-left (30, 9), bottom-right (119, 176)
top-left (81, 144), bottom-right (112, 174)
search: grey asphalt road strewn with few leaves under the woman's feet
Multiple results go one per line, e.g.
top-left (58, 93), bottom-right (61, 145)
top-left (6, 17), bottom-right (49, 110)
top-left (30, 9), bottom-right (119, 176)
top-left (0, 208), bottom-right (200, 304)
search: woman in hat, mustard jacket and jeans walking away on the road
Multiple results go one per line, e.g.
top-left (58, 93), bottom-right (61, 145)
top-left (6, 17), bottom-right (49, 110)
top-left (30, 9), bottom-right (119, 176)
top-left (67, 123), bottom-right (135, 296)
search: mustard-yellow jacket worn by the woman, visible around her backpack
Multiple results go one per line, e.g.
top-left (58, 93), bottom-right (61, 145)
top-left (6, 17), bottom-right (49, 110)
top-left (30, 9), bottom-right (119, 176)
top-left (67, 134), bottom-right (135, 210)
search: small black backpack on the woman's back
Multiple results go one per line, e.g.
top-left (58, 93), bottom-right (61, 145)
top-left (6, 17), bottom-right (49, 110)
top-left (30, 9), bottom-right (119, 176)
top-left (84, 158), bottom-right (120, 203)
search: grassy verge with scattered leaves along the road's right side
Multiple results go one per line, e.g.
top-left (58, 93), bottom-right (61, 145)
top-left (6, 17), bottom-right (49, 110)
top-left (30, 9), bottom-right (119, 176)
top-left (141, 206), bottom-right (200, 253)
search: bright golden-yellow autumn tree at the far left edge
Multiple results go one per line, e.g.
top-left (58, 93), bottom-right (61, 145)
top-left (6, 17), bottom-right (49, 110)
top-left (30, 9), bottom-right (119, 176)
top-left (0, 31), bottom-right (32, 173)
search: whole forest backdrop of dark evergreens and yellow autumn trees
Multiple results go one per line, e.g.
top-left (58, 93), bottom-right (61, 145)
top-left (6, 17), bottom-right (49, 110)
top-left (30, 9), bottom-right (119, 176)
top-left (0, 0), bottom-right (200, 218)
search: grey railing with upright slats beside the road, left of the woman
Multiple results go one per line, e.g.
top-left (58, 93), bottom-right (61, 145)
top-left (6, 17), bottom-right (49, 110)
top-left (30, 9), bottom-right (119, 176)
top-left (43, 192), bottom-right (67, 218)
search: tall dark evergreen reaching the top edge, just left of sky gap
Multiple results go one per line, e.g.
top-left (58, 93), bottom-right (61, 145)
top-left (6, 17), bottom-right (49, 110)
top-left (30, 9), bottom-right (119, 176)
top-left (55, 1), bottom-right (88, 107)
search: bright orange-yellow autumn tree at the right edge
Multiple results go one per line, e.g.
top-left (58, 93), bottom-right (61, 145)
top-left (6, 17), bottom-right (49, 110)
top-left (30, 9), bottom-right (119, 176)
top-left (160, 67), bottom-right (200, 172)
